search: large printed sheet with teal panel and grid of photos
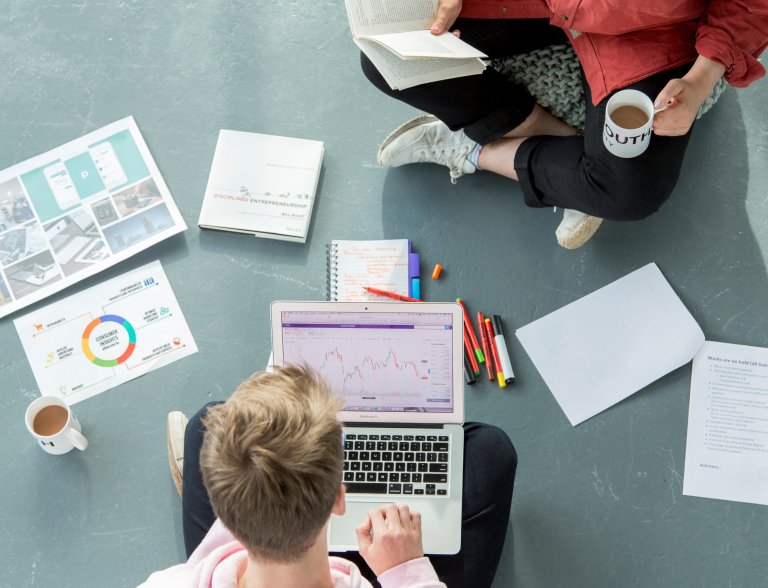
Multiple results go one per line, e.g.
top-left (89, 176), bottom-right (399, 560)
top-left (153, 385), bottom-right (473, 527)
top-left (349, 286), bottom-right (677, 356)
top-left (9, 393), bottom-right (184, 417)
top-left (0, 117), bottom-right (187, 318)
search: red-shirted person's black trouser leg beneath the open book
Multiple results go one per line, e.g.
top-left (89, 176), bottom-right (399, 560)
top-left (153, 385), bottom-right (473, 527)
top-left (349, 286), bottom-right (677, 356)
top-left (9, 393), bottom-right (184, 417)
top-left (360, 18), bottom-right (568, 145)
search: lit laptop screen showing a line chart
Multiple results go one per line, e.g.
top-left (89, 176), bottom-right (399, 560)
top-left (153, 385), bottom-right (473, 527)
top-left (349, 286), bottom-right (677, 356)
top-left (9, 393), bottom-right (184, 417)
top-left (279, 305), bottom-right (456, 413)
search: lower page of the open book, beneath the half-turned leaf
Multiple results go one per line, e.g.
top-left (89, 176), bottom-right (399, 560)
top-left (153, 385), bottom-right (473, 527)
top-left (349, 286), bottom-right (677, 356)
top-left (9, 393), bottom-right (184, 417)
top-left (355, 39), bottom-right (485, 90)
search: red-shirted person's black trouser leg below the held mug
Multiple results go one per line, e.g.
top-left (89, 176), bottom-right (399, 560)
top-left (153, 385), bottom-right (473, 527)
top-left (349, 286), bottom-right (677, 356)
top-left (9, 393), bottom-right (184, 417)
top-left (515, 64), bottom-right (693, 221)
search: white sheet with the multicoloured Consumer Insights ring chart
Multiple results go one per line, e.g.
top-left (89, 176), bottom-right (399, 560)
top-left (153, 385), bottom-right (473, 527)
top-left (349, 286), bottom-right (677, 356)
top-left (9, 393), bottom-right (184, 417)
top-left (13, 261), bottom-right (197, 404)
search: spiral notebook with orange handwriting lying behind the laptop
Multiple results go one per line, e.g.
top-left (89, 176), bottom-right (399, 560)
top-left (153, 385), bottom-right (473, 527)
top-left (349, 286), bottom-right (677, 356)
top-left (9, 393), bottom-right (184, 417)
top-left (328, 239), bottom-right (419, 302)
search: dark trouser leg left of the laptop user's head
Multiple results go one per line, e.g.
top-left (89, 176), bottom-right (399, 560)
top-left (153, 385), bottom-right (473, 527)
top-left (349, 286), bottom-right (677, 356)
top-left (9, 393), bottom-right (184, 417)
top-left (181, 401), bottom-right (221, 558)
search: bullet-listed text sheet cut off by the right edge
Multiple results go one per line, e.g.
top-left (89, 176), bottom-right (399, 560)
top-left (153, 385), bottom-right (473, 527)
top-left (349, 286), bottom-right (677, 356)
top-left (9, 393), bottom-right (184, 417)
top-left (683, 341), bottom-right (768, 504)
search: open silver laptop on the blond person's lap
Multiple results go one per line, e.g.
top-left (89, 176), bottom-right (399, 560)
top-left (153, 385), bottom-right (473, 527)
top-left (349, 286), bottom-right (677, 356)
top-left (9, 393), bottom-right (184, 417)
top-left (270, 302), bottom-right (464, 554)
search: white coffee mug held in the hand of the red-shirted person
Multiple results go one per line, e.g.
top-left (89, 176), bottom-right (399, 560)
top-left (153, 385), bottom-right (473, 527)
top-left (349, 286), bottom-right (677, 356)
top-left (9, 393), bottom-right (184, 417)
top-left (603, 90), bottom-right (654, 158)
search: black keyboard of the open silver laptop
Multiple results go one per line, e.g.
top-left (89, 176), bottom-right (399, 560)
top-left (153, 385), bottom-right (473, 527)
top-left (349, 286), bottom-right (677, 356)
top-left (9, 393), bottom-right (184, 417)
top-left (344, 433), bottom-right (451, 496)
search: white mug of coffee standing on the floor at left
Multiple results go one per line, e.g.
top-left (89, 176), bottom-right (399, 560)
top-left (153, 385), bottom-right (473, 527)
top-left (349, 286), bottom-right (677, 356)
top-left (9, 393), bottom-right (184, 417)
top-left (25, 396), bottom-right (88, 455)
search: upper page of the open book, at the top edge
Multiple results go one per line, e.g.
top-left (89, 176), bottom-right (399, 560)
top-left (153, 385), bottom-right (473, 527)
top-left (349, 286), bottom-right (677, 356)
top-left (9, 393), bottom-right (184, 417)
top-left (344, 0), bottom-right (437, 37)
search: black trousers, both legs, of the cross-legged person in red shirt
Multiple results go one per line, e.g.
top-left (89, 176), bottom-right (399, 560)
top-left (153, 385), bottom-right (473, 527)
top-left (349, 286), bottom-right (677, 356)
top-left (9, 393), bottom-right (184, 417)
top-left (361, 18), bottom-right (691, 220)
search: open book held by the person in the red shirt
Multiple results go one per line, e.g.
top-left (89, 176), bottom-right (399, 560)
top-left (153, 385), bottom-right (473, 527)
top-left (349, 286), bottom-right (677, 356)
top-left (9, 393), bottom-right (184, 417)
top-left (344, 0), bottom-right (487, 90)
